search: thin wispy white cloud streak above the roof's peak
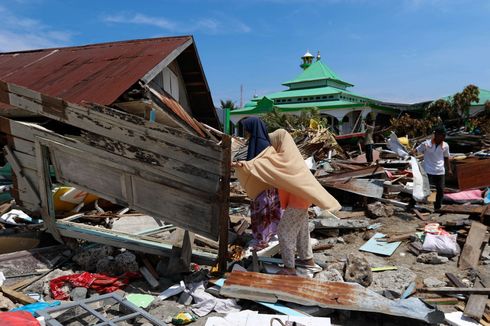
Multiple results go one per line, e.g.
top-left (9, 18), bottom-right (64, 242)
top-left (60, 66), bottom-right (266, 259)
top-left (102, 13), bottom-right (252, 34)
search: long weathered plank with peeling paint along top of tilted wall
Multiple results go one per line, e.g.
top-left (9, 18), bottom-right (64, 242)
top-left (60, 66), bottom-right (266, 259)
top-left (0, 82), bottom-right (221, 160)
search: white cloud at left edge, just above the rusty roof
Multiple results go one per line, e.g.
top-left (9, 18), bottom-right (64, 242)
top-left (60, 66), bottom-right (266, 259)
top-left (0, 6), bottom-right (72, 52)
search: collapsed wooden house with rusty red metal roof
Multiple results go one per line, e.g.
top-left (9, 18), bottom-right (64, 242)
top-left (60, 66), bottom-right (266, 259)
top-left (0, 36), bottom-right (230, 270)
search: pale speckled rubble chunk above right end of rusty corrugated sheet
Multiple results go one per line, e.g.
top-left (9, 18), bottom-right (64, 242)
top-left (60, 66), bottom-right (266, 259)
top-left (369, 267), bottom-right (417, 298)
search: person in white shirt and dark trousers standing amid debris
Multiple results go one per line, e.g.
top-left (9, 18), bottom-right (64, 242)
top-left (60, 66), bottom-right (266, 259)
top-left (416, 126), bottom-right (452, 210)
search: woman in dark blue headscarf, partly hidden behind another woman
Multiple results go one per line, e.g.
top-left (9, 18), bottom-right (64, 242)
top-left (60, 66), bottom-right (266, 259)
top-left (235, 117), bottom-right (281, 249)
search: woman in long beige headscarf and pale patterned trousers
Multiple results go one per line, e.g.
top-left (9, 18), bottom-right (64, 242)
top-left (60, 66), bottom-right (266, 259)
top-left (237, 129), bottom-right (341, 275)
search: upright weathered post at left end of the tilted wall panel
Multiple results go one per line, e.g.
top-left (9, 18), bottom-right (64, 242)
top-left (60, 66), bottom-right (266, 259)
top-left (35, 141), bottom-right (64, 243)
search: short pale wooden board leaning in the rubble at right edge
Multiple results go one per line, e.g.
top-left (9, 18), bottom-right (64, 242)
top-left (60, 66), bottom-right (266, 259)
top-left (458, 221), bottom-right (487, 269)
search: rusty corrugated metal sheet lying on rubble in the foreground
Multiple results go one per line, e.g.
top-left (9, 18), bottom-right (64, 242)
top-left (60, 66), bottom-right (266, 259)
top-left (220, 272), bottom-right (444, 323)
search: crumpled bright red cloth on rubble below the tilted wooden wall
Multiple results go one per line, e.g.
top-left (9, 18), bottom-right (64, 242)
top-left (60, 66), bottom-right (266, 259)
top-left (49, 272), bottom-right (140, 300)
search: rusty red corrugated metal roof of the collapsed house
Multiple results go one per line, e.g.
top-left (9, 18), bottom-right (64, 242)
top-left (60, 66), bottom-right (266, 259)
top-left (0, 36), bottom-right (191, 105)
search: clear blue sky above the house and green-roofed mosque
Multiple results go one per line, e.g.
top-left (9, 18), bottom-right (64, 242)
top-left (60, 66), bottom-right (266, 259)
top-left (0, 0), bottom-right (490, 103)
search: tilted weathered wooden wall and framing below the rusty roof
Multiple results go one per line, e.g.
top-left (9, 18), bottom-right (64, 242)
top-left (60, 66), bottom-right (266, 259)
top-left (0, 82), bottom-right (231, 270)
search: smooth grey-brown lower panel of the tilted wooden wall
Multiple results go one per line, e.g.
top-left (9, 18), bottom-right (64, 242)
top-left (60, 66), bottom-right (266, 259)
top-left (39, 138), bottom-right (223, 240)
